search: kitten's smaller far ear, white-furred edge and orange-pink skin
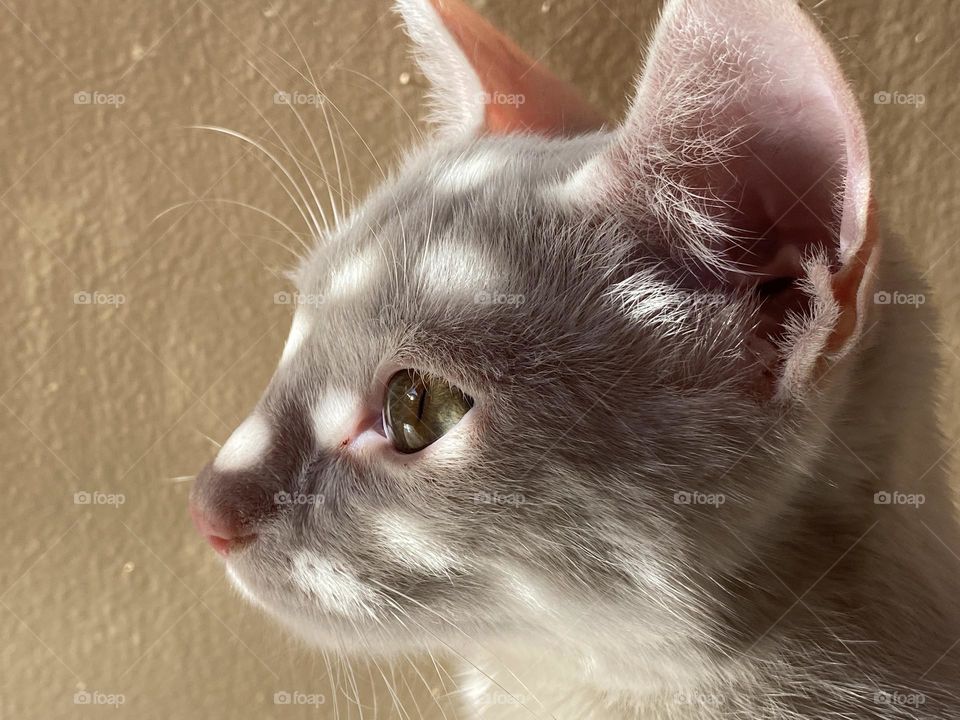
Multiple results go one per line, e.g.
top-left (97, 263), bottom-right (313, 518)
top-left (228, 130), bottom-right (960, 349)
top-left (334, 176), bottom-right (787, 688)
top-left (396, 0), bottom-right (604, 135)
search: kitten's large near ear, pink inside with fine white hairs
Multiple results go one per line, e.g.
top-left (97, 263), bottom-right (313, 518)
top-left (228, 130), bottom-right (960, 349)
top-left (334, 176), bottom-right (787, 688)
top-left (565, 0), bottom-right (877, 395)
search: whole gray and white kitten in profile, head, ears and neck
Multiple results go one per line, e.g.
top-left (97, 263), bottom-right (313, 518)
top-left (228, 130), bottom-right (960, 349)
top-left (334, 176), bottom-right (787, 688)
top-left (191, 0), bottom-right (960, 720)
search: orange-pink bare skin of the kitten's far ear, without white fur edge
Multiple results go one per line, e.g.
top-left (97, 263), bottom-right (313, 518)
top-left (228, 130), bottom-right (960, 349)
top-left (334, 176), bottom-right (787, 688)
top-left (430, 0), bottom-right (604, 135)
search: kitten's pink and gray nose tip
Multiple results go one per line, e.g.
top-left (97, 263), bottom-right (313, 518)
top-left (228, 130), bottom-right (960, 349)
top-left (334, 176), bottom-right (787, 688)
top-left (190, 463), bottom-right (277, 556)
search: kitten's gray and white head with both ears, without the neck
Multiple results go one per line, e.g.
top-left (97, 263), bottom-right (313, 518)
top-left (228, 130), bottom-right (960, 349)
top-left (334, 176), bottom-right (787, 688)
top-left (192, 0), bottom-right (877, 664)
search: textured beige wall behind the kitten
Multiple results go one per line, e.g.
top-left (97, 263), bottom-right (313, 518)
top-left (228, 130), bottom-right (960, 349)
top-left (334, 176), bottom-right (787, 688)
top-left (0, 0), bottom-right (960, 720)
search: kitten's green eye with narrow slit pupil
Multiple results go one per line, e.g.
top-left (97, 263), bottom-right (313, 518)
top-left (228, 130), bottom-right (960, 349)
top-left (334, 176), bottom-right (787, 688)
top-left (383, 370), bottom-right (473, 453)
